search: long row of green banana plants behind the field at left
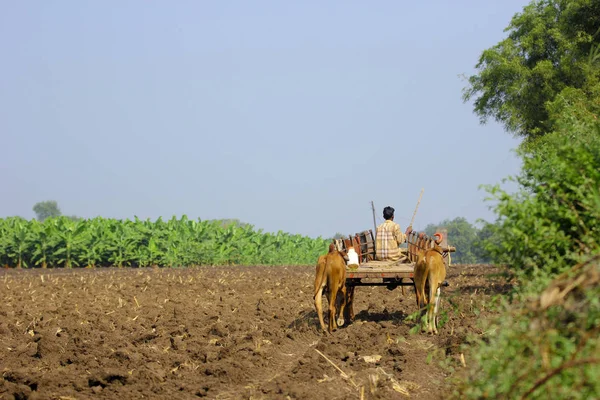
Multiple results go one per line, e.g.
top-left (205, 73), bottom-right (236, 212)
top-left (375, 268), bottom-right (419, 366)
top-left (0, 215), bottom-right (328, 268)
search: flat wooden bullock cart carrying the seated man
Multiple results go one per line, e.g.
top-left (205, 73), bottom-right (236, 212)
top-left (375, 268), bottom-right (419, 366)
top-left (336, 230), bottom-right (456, 292)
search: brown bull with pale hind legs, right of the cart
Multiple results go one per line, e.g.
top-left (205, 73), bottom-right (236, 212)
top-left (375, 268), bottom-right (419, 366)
top-left (414, 234), bottom-right (446, 334)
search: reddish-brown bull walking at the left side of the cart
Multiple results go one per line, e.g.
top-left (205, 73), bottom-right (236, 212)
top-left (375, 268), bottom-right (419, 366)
top-left (313, 243), bottom-right (347, 333)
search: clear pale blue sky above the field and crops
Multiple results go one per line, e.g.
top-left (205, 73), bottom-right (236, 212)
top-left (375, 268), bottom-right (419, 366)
top-left (0, 0), bottom-right (528, 237)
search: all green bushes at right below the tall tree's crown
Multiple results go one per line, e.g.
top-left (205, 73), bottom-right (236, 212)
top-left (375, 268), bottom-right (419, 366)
top-left (454, 114), bottom-right (600, 400)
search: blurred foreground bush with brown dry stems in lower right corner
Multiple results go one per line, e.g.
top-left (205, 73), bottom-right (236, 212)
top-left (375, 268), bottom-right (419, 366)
top-left (454, 255), bottom-right (600, 399)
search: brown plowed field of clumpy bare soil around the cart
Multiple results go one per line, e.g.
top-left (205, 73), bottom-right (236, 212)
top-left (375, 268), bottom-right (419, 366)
top-left (0, 265), bottom-right (507, 399)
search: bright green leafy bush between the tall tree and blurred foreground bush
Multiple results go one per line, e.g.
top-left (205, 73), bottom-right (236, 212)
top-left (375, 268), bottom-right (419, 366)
top-left (487, 124), bottom-right (600, 279)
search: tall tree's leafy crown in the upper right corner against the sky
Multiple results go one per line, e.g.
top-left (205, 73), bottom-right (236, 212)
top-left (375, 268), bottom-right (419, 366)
top-left (463, 0), bottom-right (600, 142)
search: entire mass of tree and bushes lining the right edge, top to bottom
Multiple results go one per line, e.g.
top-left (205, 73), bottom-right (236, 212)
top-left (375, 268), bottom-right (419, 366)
top-left (455, 0), bottom-right (600, 399)
